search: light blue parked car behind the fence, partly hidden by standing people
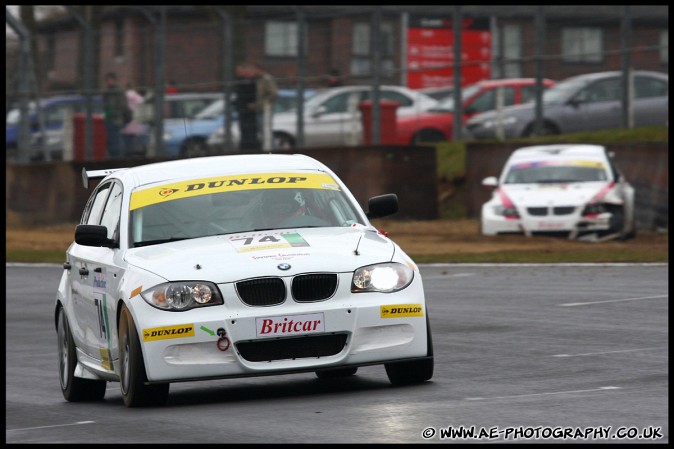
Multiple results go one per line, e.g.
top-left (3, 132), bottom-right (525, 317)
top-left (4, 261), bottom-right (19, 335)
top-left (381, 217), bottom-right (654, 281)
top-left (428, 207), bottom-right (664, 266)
top-left (164, 89), bottom-right (316, 157)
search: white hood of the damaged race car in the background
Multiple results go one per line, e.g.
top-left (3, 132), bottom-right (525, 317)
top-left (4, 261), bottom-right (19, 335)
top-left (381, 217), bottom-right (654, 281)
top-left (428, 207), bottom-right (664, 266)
top-left (501, 182), bottom-right (608, 207)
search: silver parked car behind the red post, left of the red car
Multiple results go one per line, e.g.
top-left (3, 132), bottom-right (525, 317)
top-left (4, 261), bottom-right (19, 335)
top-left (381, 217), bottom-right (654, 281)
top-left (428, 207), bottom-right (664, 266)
top-left (209, 86), bottom-right (437, 149)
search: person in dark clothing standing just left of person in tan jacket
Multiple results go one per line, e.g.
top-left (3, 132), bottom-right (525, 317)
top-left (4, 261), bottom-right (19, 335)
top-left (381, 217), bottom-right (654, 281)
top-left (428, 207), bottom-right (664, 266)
top-left (234, 63), bottom-right (260, 153)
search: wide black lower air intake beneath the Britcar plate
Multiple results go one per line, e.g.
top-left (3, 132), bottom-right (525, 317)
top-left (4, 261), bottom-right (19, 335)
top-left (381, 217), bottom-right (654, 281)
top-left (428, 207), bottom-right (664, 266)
top-left (235, 334), bottom-right (347, 362)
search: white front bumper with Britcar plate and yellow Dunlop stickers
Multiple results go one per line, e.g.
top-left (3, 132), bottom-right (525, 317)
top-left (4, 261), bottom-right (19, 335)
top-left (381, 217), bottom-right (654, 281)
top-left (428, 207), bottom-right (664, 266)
top-left (137, 274), bottom-right (428, 382)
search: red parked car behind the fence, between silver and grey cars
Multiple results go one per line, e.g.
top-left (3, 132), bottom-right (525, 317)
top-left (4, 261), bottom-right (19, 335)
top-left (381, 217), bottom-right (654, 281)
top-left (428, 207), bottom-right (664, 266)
top-left (397, 78), bottom-right (555, 145)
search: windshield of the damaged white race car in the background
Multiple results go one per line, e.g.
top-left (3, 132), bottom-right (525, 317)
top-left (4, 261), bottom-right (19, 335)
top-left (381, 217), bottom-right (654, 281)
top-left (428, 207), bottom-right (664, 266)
top-left (505, 161), bottom-right (608, 184)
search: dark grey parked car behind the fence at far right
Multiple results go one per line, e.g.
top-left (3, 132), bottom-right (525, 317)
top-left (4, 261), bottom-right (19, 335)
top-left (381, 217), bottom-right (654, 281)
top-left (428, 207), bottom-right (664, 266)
top-left (466, 71), bottom-right (669, 139)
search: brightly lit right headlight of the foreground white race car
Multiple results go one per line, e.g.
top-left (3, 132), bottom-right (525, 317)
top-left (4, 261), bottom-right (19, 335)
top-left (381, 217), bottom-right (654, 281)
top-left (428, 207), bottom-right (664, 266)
top-left (351, 262), bottom-right (414, 293)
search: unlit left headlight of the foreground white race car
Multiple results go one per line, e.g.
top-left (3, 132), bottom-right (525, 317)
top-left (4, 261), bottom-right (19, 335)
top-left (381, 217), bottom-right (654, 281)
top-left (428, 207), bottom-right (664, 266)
top-left (140, 281), bottom-right (224, 312)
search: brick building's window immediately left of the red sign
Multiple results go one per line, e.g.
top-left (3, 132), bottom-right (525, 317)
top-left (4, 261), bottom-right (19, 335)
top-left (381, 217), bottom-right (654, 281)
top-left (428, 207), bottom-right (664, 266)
top-left (351, 22), bottom-right (394, 76)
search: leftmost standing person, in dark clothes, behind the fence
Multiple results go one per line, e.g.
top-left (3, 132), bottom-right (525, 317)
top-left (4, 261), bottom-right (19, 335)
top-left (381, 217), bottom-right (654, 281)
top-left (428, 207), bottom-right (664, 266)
top-left (103, 72), bottom-right (128, 158)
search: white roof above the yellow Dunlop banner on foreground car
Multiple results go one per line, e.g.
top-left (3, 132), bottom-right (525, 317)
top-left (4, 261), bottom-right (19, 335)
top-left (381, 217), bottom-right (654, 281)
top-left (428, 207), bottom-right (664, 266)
top-left (103, 153), bottom-right (330, 188)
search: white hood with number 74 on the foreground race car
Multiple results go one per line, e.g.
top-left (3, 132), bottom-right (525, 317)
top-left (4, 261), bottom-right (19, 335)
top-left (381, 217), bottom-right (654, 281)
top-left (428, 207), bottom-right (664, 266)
top-left (126, 226), bottom-right (395, 283)
